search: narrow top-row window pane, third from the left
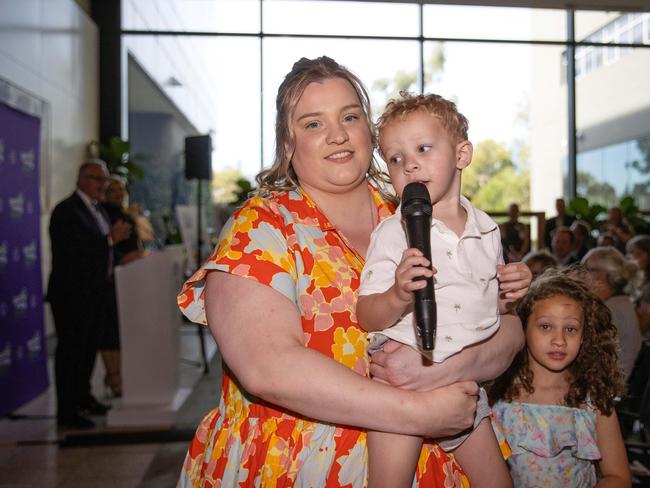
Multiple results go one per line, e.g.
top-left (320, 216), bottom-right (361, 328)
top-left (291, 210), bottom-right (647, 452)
top-left (423, 5), bottom-right (566, 41)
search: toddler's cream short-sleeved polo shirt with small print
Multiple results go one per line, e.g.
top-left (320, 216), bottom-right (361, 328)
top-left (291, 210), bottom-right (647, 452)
top-left (359, 196), bottom-right (503, 362)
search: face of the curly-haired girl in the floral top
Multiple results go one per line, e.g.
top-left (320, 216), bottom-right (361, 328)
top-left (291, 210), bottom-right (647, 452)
top-left (526, 295), bottom-right (583, 373)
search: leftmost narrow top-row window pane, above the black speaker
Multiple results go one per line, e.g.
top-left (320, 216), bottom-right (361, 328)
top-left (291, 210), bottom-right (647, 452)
top-left (122, 0), bottom-right (260, 33)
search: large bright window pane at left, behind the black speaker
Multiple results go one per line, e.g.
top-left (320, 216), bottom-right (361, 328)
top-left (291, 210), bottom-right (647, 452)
top-left (125, 36), bottom-right (261, 176)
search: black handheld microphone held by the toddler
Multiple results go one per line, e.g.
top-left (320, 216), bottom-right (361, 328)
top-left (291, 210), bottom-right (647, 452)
top-left (402, 182), bottom-right (437, 351)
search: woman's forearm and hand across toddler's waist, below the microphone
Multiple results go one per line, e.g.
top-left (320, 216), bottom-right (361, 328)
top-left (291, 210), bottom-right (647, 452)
top-left (370, 315), bottom-right (524, 390)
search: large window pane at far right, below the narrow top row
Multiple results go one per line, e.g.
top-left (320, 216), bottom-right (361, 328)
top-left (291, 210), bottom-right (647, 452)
top-left (576, 48), bottom-right (650, 209)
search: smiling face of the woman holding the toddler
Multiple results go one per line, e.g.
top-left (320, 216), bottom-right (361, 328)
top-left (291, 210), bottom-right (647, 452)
top-left (286, 78), bottom-right (372, 193)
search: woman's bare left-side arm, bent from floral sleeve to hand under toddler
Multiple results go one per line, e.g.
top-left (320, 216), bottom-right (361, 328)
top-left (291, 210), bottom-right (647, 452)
top-left (205, 272), bottom-right (477, 437)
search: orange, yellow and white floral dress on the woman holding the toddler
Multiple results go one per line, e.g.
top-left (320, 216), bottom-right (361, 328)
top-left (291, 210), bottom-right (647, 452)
top-left (178, 187), bottom-right (469, 488)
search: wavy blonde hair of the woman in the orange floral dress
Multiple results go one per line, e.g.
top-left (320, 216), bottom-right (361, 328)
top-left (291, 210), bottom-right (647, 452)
top-left (255, 56), bottom-right (396, 203)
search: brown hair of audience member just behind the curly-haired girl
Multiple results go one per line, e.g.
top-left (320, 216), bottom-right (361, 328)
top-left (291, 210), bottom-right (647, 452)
top-left (582, 246), bottom-right (643, 297)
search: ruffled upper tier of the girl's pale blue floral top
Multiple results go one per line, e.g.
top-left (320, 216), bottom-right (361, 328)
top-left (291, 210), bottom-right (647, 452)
top-left (493, 402), bottom-right (601, 461)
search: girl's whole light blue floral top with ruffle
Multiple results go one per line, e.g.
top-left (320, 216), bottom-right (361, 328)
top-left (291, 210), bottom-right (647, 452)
top-left (492, 401), bottom-right (601, 488)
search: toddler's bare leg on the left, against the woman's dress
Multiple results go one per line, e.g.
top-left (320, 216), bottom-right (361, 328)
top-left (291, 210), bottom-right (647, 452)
top-left (368, 431), bottom-right (422, 488)
